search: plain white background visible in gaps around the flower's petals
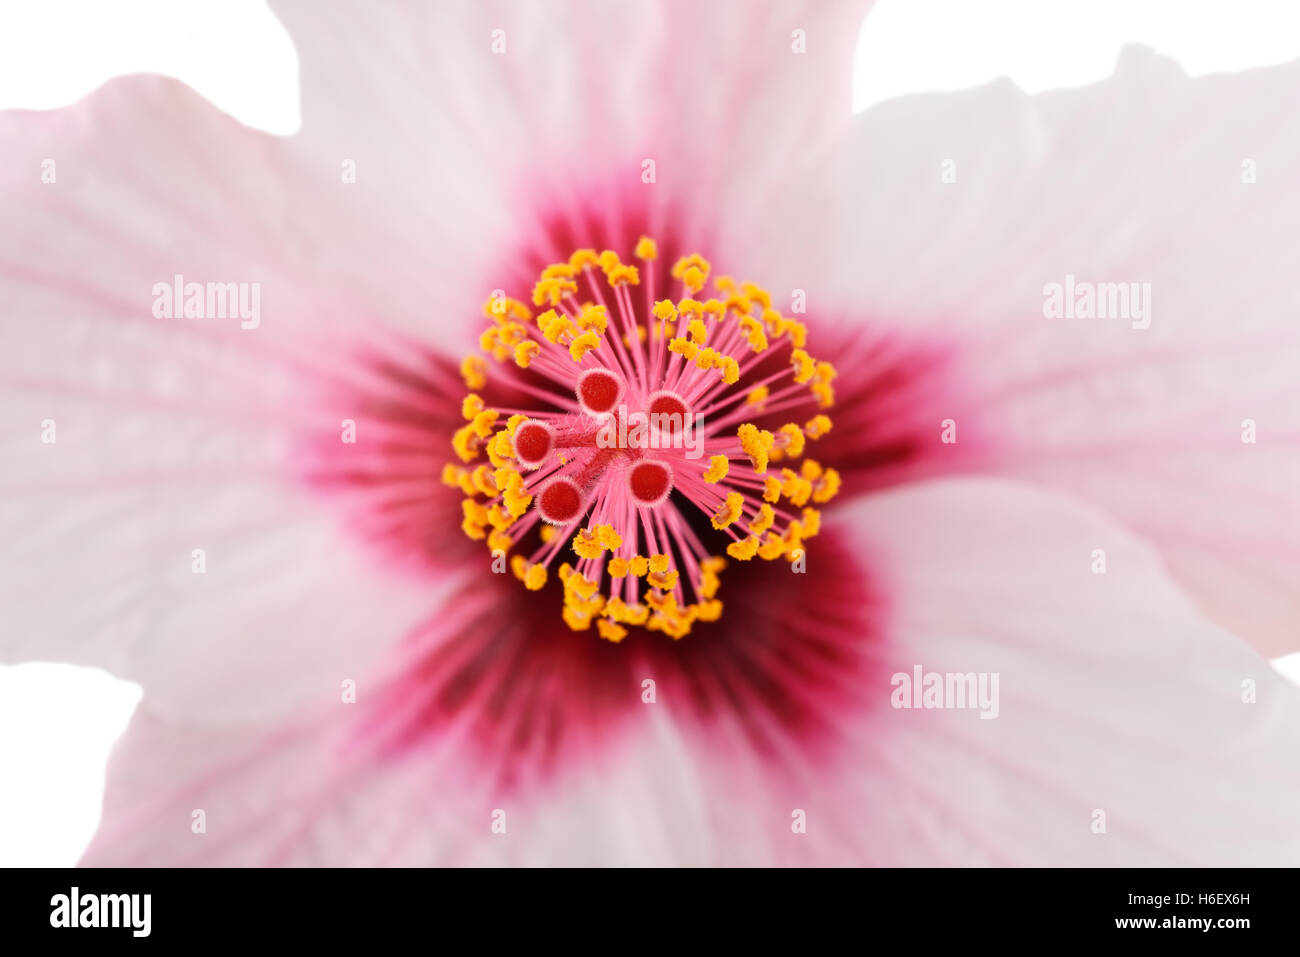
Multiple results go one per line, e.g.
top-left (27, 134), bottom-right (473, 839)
top-left (0, 0), bottom-right (1300, 866)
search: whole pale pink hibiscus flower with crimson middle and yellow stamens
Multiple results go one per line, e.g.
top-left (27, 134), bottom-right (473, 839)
top-left (0, 1), bottom-right (1300, 865)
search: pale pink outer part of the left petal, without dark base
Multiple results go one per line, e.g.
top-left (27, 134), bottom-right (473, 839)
top-left (0, 78), bottom-right (465, 718)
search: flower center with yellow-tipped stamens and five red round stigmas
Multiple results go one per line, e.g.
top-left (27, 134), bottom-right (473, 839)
top-left (442, 238), bottom-right (840, 641)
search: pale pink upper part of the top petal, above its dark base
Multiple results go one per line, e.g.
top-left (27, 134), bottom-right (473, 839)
top-left (272, 0), bottom-right (870, 247)
